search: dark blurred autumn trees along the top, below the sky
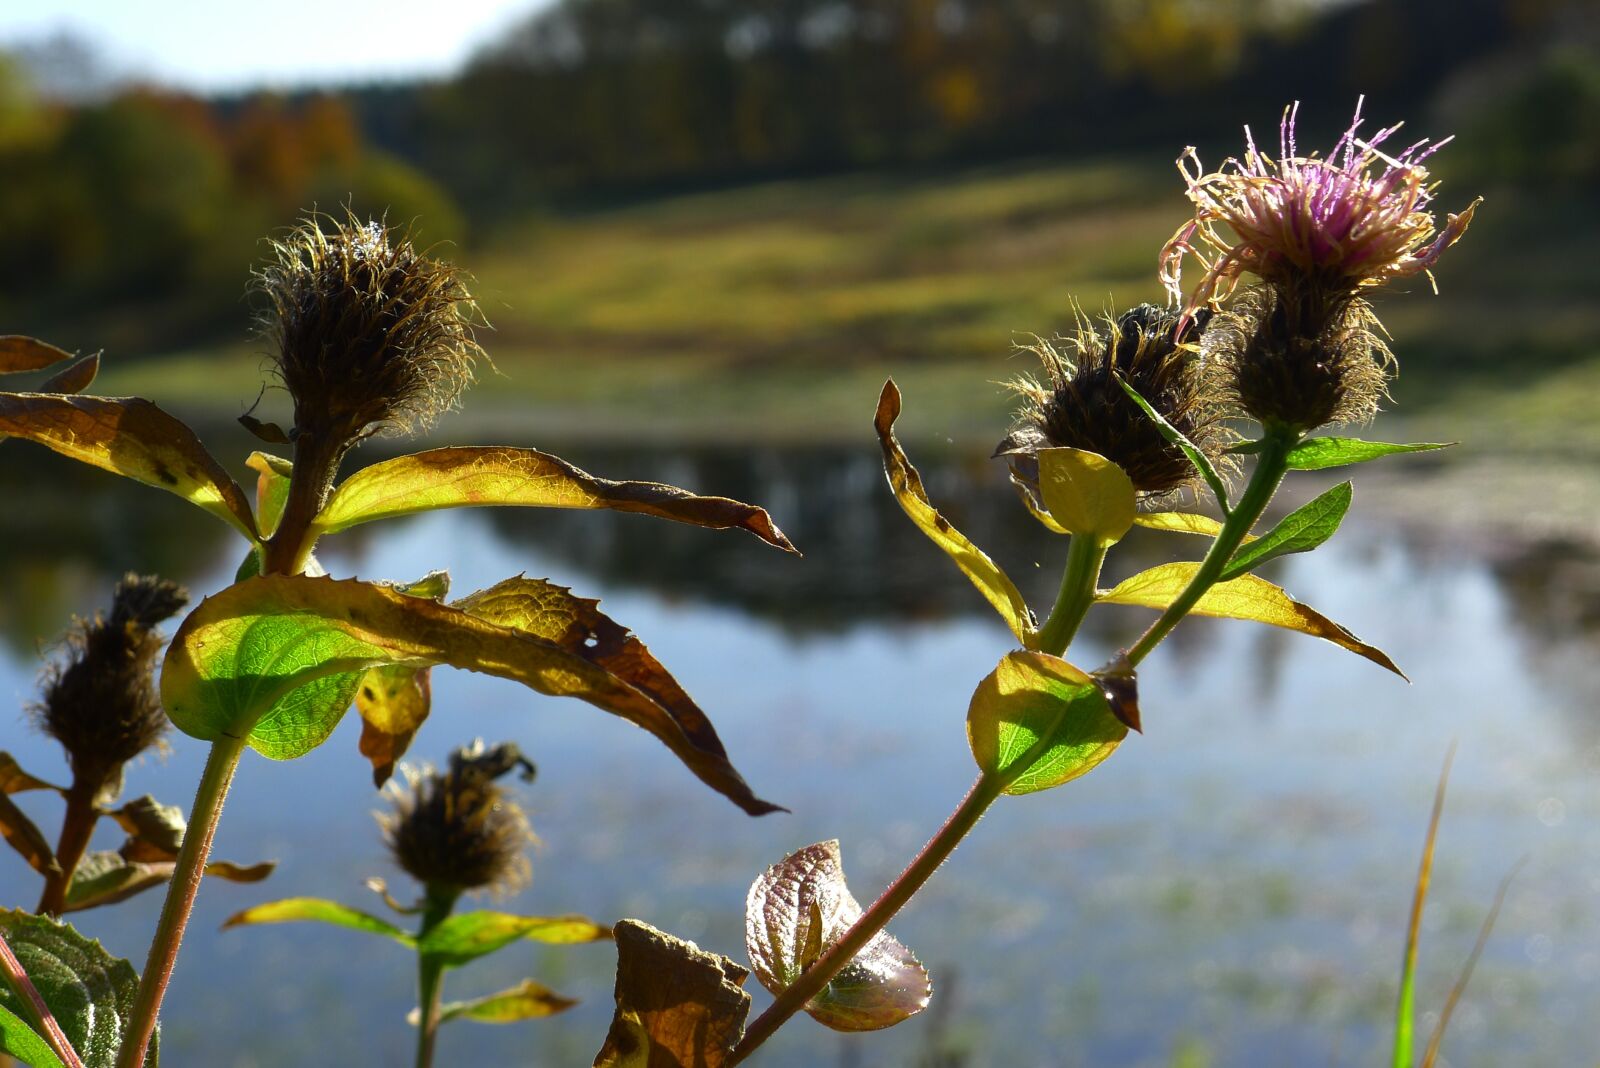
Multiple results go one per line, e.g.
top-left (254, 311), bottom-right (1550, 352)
top-left (0, 0), bottom-right (1600, 352)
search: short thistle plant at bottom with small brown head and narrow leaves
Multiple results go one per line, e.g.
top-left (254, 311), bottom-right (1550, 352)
top-left (224, 742), bottom-right (611, 1068)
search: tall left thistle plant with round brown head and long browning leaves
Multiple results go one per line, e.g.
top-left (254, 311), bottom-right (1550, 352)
top-left (0, 216), bottom-right (794, 1068)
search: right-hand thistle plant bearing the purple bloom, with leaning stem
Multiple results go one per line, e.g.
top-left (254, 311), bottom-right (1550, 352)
top-left (572, 109), bottom-right (1477, 1068)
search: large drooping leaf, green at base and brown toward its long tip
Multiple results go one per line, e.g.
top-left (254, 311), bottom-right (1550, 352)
top-left (162, 576), bottom-right (778, 815)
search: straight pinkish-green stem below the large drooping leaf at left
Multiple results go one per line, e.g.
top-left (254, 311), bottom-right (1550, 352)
top-left (117, 737), bottom-right (245, 1068)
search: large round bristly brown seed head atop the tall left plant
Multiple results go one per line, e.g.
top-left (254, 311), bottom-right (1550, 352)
top-left (256, 214), bottom-right (483, 446)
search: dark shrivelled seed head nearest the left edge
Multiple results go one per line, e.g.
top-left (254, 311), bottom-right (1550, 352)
top-left (30, 574), bottom-right (189, 791)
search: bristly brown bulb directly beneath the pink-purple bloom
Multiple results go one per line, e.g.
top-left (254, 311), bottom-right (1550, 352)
top-left (1200, 283), bottom-right (1395, 432)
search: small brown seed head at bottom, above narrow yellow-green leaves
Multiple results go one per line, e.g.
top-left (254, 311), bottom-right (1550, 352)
top-left (378, 742), bottom-right (534, 894)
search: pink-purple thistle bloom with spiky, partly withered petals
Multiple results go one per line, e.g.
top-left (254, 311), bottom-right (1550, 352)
top-left (1160, 98), bottom-right (1483, 320)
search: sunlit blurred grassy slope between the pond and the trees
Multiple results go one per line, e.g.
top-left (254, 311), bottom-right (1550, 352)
top-left (102, 160), bottom-right (1600, 456)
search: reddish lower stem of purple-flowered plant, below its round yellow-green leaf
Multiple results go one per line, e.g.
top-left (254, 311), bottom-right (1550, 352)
top-left (723, 770), bottom-right (1004, 1068)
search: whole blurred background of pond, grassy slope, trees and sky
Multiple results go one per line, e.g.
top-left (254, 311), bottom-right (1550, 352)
top-left (0, 0), bottom-right (1600, 1068)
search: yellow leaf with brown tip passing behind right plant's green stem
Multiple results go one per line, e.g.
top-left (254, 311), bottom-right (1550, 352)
top-left (1096, 563), bottom-right (1405, 678)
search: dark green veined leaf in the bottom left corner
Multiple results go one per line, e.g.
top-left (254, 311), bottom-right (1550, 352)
top-left (0, 910), bottom-right (160, 1068)
